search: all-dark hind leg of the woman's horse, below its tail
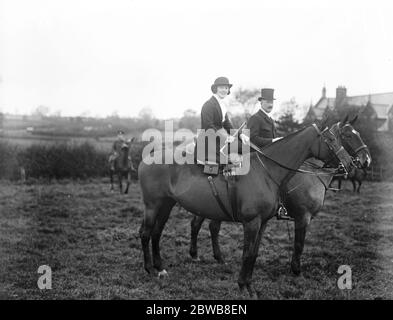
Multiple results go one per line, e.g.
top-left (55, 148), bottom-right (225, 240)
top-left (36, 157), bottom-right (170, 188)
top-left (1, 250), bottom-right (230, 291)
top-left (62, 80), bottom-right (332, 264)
top-left (139, 204), bottom-right (159, 274)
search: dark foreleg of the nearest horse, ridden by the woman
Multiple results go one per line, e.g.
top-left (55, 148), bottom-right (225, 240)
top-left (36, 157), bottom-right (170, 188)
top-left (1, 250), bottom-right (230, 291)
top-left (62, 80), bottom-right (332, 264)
top-left (237, 215), bottom-right (267, 299)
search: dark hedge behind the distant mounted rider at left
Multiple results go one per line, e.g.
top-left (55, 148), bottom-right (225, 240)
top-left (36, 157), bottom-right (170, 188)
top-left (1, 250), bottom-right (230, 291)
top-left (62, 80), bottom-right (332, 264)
top-left (0, 141), bottom-right (144, 180)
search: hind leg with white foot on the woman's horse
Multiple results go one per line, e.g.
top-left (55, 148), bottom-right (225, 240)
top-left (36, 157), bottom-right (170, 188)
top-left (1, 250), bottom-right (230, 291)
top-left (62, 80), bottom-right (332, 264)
top-left (151, 198), bottom-right (176, 277)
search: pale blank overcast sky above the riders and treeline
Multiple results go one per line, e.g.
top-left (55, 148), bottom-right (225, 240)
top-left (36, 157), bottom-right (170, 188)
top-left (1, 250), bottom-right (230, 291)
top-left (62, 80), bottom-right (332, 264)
top-left (0, 0), bottom-right (393, 118)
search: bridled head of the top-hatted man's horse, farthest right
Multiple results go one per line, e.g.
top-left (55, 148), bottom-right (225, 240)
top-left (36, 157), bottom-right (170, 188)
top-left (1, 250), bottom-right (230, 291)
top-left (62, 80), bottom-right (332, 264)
top-left (331, 116), bottom-right (371, 169)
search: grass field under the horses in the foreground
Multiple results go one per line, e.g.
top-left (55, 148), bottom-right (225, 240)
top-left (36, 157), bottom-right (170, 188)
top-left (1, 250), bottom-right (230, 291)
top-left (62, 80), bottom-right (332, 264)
top-left (0, 179), bottom-right (393, 299)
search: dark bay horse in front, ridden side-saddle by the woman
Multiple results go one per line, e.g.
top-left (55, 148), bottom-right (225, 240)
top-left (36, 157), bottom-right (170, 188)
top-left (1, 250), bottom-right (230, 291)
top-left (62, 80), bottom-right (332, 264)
top-left (138, 120), bottom-right (353, 298)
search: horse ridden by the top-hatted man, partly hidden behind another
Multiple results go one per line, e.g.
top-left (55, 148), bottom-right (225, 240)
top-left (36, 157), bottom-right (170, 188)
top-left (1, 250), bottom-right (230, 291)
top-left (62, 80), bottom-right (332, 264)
top-left (190, 117), bottom-right (371, 275)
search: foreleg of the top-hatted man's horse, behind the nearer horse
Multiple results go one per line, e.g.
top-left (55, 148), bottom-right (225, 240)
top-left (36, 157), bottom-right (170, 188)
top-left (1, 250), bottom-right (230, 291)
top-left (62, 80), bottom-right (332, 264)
top-left (291, 213), bottom-right (311, 276)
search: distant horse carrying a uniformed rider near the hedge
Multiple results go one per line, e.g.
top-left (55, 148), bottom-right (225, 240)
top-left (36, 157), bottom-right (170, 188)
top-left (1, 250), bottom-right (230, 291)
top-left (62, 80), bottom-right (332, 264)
top-left (109, 137), bottom-right (136, 194)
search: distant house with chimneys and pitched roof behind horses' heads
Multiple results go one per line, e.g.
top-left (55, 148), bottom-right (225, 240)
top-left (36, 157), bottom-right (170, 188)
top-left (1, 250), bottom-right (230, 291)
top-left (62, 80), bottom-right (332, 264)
top-left (304, 86), bottom-right (393, 132)
